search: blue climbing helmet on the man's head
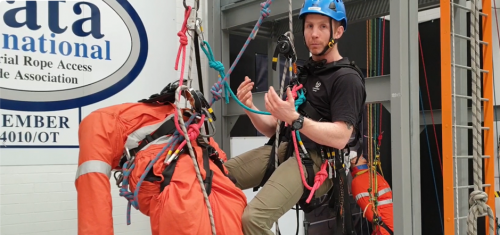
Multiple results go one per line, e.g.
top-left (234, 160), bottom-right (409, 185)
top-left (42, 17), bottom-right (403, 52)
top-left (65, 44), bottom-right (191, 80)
top-left (299, 0), bottom-right (347, 31)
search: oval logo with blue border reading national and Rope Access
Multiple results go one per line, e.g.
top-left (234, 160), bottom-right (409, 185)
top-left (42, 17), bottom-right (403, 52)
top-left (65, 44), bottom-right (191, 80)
top-left (0, 0), bottom-right (148, 111)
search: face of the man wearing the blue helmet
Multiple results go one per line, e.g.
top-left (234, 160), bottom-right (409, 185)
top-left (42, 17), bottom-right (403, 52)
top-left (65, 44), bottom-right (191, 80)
top-left (304, 14), bottom-right (343, 55)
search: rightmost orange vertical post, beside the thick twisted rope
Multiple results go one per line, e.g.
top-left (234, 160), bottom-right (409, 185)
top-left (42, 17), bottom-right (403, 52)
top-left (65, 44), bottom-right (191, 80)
top-left (481, 0), bottom-right (496, 235)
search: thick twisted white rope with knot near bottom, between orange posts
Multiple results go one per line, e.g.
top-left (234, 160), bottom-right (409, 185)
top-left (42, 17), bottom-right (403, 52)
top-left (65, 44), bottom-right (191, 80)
top-left (467, 0), bottom-right (495, 235)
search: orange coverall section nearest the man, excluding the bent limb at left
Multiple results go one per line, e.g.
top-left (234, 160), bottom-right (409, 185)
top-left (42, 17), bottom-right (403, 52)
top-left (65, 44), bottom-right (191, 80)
top-left (130, 139), bottom-right (246, 235)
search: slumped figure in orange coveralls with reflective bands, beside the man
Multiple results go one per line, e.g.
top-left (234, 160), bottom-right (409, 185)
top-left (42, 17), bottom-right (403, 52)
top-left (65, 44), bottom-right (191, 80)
top-left (75, 103), bottom-right (247, 235)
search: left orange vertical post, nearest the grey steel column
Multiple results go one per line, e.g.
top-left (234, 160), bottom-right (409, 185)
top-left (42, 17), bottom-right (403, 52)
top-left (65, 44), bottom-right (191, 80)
top-left (440, 0), bottom-right (455, 235)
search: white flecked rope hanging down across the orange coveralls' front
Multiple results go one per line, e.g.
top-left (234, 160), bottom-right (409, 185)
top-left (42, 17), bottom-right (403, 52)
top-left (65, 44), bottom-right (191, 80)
top-left (175, 85), bottom-right (216, 235)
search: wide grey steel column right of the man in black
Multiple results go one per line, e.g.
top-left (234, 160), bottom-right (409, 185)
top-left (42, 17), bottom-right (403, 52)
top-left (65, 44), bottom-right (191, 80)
top-left (390, 0), bottom-right (421, 235)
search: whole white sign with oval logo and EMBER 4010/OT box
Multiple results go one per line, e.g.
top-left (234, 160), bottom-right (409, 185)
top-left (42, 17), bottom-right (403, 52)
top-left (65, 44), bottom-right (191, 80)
top-left (0, 0), bottom-right (179, 148)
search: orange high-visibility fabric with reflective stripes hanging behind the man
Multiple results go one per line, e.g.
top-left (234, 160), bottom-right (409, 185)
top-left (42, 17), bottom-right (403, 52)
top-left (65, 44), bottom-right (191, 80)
top-left (351, 172), bottom-right (394, 235)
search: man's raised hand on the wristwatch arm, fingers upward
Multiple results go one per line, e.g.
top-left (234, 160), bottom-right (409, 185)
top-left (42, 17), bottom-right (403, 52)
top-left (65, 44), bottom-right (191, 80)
top-left (264, 86), bottom-right (299, 124)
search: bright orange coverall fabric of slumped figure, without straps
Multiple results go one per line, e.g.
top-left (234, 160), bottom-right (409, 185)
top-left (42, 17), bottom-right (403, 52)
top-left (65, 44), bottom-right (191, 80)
top-left (75, 103), bottom-right (246, 235)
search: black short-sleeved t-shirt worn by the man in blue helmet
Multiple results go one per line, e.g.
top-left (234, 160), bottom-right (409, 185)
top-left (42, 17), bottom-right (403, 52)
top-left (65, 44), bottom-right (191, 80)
top-left (294, 57), bottom-right (366, 148)
